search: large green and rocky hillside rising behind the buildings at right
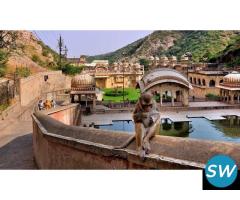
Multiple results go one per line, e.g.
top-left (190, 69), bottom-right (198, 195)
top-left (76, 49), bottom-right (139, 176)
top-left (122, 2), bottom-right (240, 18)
top-left (88, 31), bottom-right (240, 65)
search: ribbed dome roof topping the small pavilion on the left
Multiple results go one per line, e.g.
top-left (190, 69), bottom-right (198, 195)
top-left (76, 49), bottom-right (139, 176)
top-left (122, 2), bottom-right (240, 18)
top-left (71, 74), bottom-right (95, 88)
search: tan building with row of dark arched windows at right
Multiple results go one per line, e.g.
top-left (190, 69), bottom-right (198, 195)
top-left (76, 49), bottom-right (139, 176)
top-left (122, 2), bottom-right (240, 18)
top-left (188, 70), bottom-right (226, 98)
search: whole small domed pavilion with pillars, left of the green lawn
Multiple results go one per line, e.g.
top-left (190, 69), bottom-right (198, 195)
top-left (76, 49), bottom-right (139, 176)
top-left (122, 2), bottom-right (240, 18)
top-left (70, 74), bottom-right (97, 110)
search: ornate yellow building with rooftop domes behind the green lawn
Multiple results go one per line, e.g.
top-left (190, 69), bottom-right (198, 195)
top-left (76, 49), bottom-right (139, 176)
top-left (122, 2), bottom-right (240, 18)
top-left (83, 62), bottom-right (144, 88)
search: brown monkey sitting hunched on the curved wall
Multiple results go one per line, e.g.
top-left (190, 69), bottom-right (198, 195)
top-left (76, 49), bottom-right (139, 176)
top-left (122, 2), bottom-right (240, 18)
top-left (133, 92), bottom-right (160, 159)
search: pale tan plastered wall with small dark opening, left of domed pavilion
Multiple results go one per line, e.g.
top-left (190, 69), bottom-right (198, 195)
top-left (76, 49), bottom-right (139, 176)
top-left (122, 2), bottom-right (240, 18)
top-left (19, 71), bottom-right (70, 106)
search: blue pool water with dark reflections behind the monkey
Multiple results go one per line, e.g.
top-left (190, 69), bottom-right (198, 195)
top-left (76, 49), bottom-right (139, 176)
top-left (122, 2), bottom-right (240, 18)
top-left (96, 116), bottom-right (240, 143)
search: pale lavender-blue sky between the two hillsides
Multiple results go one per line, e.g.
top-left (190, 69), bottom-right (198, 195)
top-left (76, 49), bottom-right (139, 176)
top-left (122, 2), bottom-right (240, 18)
top-left (33, 30), bottom-right (153, 57)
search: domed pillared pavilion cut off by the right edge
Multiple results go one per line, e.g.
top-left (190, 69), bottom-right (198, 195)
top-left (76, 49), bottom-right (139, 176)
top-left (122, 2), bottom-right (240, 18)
top-left (217, 71), bottom-right (240, 104)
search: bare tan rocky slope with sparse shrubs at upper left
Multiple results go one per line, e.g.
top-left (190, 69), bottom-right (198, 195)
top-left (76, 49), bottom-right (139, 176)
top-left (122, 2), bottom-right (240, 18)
top-left (0, 31), bottom-right (57, 74)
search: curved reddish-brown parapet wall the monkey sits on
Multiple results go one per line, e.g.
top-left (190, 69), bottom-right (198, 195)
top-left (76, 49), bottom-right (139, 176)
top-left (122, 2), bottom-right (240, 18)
top-left (32, 106), bottom-right (240, 169)
